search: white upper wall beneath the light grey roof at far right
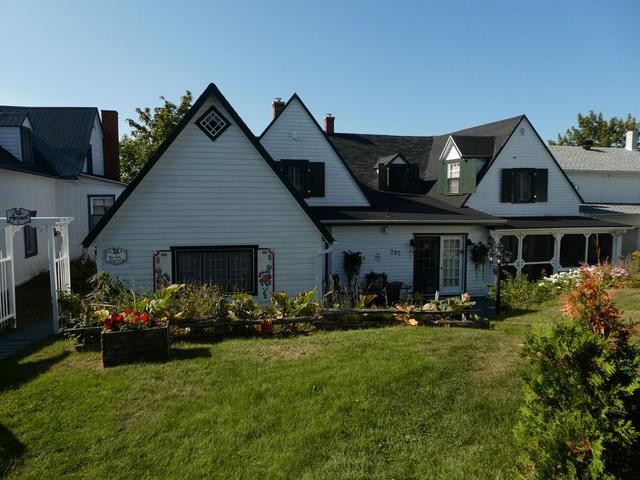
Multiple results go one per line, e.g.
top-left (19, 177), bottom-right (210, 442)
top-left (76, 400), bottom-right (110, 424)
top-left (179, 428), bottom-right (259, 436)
top-left (567, 170), bottom-right (640, 203)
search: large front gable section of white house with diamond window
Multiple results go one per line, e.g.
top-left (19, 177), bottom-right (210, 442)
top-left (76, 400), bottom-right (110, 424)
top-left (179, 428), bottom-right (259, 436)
top-left (84, 84), bottom-right (333, 301)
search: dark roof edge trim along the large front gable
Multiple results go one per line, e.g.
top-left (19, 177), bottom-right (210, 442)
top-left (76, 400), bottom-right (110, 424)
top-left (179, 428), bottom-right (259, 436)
top-left (82, 83), bottom-right (333, 247)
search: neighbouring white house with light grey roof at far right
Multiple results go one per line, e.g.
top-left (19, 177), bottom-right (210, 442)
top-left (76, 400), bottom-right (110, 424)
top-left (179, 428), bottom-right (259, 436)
top-left (550, 131), bottom-right (640, 255)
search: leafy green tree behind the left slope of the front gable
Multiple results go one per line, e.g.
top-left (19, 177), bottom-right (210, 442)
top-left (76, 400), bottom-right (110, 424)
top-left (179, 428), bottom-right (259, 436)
top-left (120, 90), bottom-right (193, 182)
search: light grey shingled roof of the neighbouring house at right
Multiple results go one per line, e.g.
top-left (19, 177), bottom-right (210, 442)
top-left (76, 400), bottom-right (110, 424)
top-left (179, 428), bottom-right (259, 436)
top-left (549, 146), bottom-right (640, 173)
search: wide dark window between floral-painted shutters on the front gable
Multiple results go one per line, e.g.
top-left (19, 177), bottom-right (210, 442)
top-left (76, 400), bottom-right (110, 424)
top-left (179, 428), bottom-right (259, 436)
top-left (172, 246), bottom-right (257, 293)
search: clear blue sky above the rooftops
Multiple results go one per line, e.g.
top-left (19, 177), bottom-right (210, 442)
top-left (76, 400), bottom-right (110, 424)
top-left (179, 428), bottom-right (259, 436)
top-left (0, 0), bottom-right (640, 139)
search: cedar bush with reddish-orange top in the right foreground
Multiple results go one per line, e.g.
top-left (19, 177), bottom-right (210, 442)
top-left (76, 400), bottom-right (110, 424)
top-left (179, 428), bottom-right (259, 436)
top-left (516, 269), bottom-right (640, 479)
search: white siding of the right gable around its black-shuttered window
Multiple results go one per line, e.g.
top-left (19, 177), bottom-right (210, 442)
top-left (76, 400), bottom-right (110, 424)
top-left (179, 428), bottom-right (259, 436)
top-left (467, 120), bottom-right (580, 217)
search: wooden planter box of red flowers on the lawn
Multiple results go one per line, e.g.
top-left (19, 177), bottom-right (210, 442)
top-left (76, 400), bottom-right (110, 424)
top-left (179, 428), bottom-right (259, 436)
top-left (95, 306), bottom-right (169, 367)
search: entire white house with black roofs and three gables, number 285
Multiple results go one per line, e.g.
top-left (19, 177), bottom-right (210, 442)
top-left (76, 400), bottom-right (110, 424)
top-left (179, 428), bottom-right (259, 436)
top-left (84, 85), bottom-right (627, 300)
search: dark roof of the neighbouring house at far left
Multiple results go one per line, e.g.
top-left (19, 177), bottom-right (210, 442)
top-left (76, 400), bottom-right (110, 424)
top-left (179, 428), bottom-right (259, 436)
top-left (0, 105), bottom-right (99, 177)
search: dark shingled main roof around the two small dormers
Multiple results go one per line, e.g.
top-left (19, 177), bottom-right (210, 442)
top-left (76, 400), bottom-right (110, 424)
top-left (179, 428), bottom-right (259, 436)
top-left (329, 115), bottom-right (525, 208)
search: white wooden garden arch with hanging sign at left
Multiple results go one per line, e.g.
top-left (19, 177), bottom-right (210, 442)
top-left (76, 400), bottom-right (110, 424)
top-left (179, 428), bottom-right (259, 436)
top-left (0, 217), bottom-right (73, 333)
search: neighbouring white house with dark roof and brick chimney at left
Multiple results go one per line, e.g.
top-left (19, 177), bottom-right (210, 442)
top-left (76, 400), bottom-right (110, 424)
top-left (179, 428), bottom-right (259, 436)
top-left (0, 106), bottom-right (125, 284)
